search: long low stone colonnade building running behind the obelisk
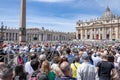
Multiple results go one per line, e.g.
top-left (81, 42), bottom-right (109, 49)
top-left (0, 27), bottom-right (75, 42)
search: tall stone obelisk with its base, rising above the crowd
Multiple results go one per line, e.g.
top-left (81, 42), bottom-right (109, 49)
top-left (19, 0), bottom-right (26, 42)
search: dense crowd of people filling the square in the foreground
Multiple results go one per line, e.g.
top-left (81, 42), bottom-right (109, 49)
top-left (0, 42), bottom-right (120, 80)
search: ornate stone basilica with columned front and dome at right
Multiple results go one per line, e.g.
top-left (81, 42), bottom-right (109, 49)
top-left (76, 7), bottom-right (120, 40)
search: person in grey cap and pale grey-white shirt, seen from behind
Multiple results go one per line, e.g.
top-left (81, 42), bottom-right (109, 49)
top-left (77, 53), bottom-right (96, 80)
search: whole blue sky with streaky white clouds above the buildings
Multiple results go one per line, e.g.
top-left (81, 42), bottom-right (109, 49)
top-left (0, 0), bottom-right (120, 32)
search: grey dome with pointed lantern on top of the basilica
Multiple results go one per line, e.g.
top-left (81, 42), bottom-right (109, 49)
top-left (101, 7), bottom-right (115, 19)
